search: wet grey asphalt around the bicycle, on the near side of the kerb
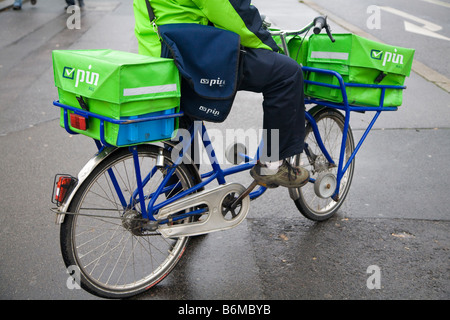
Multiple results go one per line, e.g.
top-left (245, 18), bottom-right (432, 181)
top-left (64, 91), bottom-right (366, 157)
top-left (0, 0), bottom-right (450, 300)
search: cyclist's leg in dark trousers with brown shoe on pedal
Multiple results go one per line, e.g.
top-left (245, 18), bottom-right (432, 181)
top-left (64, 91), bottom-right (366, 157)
top-left (239, 49), bottom-right (309, 187)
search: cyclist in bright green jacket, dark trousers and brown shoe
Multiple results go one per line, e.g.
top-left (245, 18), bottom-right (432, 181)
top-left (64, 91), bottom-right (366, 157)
top-left (133, 0), bottom-right (309, 188)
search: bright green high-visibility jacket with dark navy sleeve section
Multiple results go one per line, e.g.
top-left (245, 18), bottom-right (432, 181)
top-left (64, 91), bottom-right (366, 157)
top-left (133, 0), bottom-right (278, 57)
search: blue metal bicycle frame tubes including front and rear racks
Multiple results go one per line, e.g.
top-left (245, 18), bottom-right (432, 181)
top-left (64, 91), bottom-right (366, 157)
top-left (54, 67), bottom-right (406, 223)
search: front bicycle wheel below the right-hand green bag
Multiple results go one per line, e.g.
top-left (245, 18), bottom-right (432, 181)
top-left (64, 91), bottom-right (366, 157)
top-left (294, 105), bottom-right (355, 221)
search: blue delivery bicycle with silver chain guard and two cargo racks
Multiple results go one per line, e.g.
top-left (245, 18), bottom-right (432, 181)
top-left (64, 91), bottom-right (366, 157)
top-left (52, 17), bottom-right (405, 298)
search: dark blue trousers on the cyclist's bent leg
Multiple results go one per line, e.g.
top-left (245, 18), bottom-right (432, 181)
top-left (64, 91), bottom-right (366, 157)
top-left (239, 48), bottom-right (305, 161)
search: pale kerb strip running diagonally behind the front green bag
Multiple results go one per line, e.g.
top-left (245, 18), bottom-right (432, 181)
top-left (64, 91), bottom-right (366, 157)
top-left (299, 0), bottom-right (450, 93)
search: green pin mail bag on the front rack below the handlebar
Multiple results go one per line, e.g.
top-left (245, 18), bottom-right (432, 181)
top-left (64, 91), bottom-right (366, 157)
top-left (305, 34), bottom-right (414, 107)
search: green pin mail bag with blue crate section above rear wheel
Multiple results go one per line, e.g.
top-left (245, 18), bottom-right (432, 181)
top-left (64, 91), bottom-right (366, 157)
top-left (53, 49), bottom-right (180, 146)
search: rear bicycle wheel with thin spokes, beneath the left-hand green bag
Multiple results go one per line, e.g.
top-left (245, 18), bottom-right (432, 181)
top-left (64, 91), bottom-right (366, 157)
top-left (60, 145), bottom-right (194, 298)
